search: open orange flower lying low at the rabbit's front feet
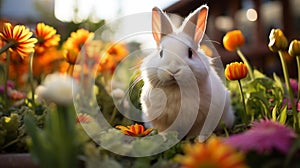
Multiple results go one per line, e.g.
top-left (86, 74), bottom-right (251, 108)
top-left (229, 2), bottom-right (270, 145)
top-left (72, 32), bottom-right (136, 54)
top-left (116, 124), bottom-right (153, 137)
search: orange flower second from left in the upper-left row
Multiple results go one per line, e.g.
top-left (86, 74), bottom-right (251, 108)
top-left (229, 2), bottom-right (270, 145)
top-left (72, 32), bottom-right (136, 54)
top-left (35, 23), bottom-right (60, 53)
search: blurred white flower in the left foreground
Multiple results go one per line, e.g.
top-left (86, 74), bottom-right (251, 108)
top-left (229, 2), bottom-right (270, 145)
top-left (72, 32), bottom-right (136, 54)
top-left (36, 73), bottom-right (78, 105)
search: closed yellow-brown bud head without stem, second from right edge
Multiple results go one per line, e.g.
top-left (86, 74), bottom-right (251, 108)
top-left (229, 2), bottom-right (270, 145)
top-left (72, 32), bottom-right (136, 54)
top-left (268, 29), bottom-right (288, 52)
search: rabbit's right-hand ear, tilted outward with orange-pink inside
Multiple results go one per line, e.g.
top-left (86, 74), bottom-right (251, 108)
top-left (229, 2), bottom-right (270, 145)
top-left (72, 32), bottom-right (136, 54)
top-left (182, 5), bottom-right (208, 44)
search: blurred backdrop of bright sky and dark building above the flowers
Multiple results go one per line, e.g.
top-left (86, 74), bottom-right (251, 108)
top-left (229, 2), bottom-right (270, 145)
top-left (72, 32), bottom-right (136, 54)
top-left (0, 0), bottom-right (300, 77)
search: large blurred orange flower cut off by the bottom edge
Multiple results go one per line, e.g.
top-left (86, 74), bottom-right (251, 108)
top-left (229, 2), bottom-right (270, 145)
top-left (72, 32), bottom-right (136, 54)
top-left (175, 137), bottom-right (247, 168)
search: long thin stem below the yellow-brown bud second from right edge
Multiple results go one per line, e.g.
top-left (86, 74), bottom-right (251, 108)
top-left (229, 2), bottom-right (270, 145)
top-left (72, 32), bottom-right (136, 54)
top-left (278, 50), bottom-right (299, 130)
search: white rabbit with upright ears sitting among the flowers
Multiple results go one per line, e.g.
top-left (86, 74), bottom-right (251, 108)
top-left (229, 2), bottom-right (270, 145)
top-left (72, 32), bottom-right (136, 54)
top-left (140, 5), bottom-right (234, 137)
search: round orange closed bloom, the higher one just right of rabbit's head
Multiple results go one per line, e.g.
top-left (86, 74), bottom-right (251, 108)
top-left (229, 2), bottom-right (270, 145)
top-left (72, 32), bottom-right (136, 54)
top-left (223, 30), bottom-right (245, 51)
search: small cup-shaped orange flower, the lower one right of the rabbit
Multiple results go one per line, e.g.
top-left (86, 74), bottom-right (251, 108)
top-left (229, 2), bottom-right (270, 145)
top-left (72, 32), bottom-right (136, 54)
top-left (225, 62), bottom-right (248, 80)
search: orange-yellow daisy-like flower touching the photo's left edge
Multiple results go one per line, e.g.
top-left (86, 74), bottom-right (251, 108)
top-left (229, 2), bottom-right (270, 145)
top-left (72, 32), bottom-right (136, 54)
top-left (0, 23), bottom-right (37, 58)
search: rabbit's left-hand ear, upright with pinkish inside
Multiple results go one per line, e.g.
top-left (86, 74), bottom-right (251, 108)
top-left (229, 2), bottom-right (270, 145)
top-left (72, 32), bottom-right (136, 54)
top-left (152, 7), bottom-right (173, 45)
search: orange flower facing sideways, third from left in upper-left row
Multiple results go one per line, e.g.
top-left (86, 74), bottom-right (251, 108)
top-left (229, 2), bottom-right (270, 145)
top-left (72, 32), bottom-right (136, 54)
top-left (63, 29), bottom-right (94, 65)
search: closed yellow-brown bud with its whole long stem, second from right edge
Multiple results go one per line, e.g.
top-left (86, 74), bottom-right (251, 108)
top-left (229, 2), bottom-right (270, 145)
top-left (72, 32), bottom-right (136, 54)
top-left (268, 29), bottom-right (299, 129)
